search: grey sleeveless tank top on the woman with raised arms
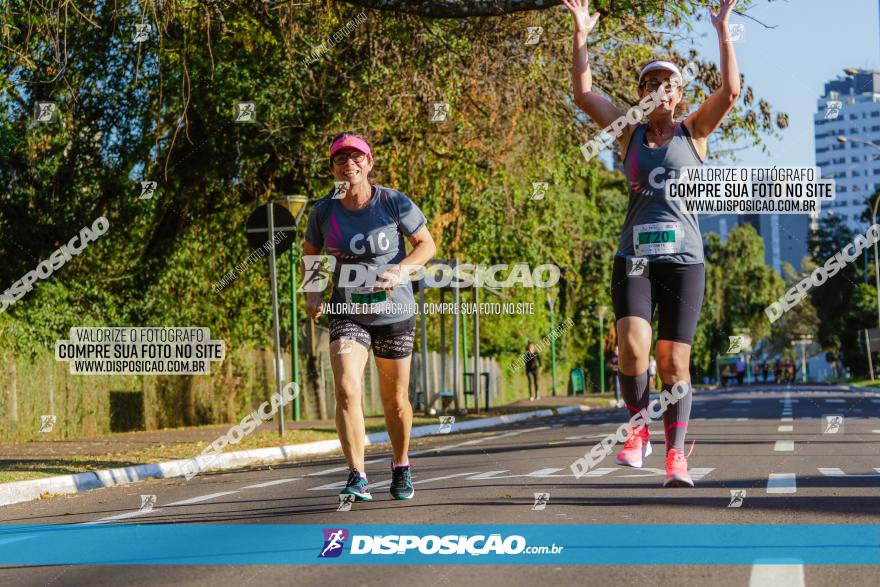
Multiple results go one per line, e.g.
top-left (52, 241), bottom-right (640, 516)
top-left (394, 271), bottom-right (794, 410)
top-left (617, 123), bottom-right (703, 265)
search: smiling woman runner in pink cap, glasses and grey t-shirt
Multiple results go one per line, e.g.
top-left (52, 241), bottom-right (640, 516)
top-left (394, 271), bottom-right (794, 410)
top-left (303, 132), bottom-right (437, 501)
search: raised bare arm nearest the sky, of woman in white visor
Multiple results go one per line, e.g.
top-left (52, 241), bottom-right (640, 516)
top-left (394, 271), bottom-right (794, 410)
top-left (685, 0), bottom-right (740, 140)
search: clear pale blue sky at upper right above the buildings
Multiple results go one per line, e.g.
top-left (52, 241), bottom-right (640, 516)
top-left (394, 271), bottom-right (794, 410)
top-left (695, 0), bottom-right (880, 166)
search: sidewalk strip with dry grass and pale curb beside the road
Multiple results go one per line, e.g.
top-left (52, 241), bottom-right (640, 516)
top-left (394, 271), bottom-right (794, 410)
top-left (0, 396), bottom-right (613, 505)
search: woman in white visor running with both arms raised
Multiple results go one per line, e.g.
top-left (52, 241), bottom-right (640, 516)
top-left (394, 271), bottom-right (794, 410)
top-left (563, 0), bottom-right (740, 487)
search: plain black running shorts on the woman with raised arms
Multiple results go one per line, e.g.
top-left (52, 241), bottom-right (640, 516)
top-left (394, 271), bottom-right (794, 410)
top-left (611, 257), bottom-right (706, 344)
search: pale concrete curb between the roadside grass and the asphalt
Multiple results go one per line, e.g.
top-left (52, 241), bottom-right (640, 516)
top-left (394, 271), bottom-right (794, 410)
top-left (0, 405), bottom-right (591, 506)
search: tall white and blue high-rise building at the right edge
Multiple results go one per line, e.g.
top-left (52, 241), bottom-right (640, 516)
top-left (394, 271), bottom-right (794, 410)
top-left (813, 69), bottom-right (880, 232)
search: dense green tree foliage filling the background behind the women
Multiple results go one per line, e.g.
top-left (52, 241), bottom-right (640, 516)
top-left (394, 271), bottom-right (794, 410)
top-left (0, 0), bottom-right (783, 384)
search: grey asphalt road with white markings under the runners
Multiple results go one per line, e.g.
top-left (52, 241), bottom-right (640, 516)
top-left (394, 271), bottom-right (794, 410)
top-left (0, 385), bottom-right (880, 587)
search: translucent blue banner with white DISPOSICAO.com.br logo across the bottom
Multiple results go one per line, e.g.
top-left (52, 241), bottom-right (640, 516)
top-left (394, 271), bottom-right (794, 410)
top-left (0, 524), bottom-right (880, 565)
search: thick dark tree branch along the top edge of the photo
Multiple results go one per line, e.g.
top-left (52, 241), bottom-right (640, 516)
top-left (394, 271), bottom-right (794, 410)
top-left (344, 0), bottom-right (562, 18)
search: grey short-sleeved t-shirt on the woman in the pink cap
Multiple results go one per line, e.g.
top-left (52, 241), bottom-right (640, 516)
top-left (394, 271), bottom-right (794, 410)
top-left (306, 185), bottom-right (428, 326)
